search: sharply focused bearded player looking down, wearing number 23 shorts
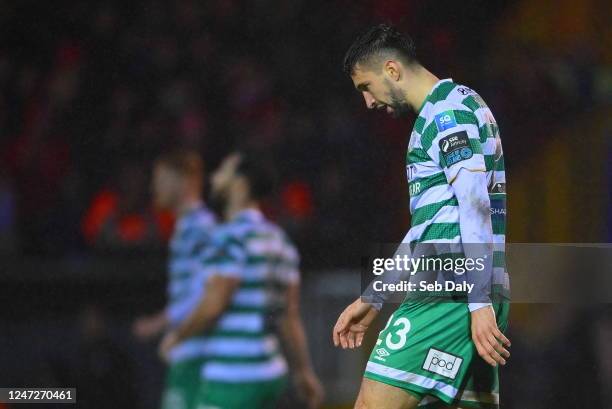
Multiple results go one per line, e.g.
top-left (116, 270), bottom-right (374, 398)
top-left (333, 24), bottom-right (510, 409)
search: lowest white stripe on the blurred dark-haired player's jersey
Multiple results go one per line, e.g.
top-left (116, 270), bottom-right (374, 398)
top-left (201, 355), bottom-right (287, 383)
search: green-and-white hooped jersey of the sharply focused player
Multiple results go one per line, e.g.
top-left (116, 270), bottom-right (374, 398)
top-left (404, 79), bottom-right (508, 287)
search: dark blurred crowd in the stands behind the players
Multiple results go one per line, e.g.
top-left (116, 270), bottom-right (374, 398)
top-left (0, 0), bottom-right (610, 266)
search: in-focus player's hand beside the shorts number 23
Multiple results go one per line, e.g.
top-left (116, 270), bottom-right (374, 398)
top-left (332, 298), bottom-right (378, 349)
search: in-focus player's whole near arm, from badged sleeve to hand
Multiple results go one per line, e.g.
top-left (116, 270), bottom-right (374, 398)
top-left (430, 103), bottom-right (510, 365)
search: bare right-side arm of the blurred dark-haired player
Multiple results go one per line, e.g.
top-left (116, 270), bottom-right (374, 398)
top-left (280, 283), bottom-right (323, 408)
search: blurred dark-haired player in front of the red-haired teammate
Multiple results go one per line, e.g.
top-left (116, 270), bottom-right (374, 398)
top-left (163, 153), bottom-right (322, 409)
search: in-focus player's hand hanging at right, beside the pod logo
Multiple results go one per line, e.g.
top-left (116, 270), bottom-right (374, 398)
top-left (471, 306), bottom-right (510, 366)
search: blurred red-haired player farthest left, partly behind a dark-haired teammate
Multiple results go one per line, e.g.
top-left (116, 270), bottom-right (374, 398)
top-left (133, 151), bottom-right (215, 409)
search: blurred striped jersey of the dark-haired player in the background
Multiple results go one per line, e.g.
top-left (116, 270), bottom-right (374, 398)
top-left (202, 209), bottom-right (299, 382)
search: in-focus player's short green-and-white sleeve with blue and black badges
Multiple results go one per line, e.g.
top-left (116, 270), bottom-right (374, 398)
top-left (423, 103), bottom-right (486, 183)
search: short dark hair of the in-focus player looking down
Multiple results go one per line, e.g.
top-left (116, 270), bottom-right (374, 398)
top-left (343, 24), bottom-right (417, 75)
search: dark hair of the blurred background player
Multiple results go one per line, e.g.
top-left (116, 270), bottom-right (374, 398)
top-left (236, 151), bottom-right (276, 200)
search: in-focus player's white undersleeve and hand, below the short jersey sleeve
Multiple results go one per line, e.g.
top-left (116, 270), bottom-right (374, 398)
top-left (452, 168), bottom-right (510, 366)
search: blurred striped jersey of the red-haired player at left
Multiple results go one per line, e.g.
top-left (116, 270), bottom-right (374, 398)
top-left (166, 206), bottom-right (215, 360)
